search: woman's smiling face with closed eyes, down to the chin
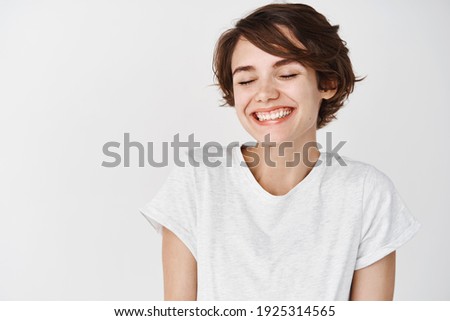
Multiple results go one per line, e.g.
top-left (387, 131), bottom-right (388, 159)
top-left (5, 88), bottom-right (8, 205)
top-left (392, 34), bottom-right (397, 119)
top-left (231, 29), bottom-right (335, 143)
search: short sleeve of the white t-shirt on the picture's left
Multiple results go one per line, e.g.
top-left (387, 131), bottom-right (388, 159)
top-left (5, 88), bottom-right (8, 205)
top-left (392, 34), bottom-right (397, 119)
top-left (139, 152), bottom-right (197, 259)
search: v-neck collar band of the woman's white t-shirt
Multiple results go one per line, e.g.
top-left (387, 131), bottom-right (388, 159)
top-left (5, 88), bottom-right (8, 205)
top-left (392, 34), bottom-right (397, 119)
top-left (233, 145), bottom-right (326, 201)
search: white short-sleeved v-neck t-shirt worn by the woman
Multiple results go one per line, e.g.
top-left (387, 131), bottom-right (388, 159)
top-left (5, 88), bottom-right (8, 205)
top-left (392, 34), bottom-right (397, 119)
top-left (139, 147), bottom-right (421, 301)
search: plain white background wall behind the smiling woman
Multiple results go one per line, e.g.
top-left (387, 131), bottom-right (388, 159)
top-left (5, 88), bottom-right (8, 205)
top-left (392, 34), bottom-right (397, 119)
top-left (0, 0), bottom-right (450, 300)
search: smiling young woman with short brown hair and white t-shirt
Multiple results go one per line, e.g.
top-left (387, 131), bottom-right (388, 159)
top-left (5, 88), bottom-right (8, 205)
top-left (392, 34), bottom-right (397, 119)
top-left (141, 4), bottom-right (420, 300)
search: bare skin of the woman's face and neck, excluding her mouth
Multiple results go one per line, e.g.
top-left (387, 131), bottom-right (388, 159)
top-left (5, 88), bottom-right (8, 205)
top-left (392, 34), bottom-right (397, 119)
top-left (232, 28), bottom-right (336, 195)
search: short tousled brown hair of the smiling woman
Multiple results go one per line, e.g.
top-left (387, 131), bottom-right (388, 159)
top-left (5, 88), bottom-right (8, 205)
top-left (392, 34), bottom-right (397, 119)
top-left (213, 3), bottom-right (364, 129)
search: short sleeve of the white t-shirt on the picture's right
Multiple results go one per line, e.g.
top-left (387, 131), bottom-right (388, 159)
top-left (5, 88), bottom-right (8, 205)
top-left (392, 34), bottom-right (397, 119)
top-left (355, 166), bottom-right (421, 270)
